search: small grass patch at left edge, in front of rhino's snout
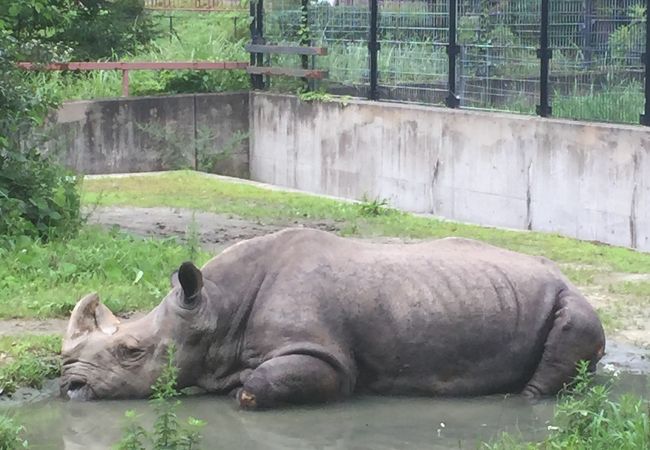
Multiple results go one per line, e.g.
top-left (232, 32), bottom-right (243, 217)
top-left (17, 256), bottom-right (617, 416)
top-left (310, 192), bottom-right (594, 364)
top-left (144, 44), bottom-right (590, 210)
top-left (0, 334), bottom-right (61, 394)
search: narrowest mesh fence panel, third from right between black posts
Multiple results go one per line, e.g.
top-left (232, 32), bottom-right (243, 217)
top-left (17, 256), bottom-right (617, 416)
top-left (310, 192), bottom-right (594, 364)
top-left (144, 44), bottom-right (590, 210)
top-left (378, 0), bottom-right (449, 104)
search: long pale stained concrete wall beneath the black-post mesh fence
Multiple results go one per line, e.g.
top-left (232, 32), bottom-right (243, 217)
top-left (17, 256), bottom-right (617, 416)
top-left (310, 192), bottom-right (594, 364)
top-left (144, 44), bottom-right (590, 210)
top-left (250, 93), bottom-right (650, 251)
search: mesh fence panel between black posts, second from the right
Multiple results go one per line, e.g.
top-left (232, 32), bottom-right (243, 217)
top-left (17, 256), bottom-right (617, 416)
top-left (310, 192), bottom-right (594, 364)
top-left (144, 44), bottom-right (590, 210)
top-left (457, 0), bottom-right (541, 114)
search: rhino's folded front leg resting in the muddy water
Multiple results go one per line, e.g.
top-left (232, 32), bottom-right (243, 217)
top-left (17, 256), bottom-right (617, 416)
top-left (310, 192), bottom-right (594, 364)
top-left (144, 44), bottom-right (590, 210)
top-left (237, 355), bottom-right (344, 409)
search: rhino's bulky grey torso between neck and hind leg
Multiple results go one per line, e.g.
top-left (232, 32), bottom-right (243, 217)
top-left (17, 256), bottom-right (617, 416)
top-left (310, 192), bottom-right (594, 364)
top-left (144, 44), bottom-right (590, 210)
top-left (239, 230), bottom-right (566, 394)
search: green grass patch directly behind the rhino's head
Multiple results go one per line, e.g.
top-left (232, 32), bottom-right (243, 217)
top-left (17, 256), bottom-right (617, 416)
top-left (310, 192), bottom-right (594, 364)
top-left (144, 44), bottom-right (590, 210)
top-left (0, 227), bottom-right (208, 318)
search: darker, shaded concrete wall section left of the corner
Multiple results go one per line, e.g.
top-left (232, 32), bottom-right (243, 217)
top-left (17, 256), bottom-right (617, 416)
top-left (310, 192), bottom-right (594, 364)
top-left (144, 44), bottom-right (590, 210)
top-left (45, 93), bottom-right (249, 178)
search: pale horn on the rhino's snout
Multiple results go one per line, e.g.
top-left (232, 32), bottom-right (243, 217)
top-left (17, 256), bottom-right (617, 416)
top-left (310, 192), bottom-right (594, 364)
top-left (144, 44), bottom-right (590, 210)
top-left (65, 293), bottom-right (120, 341)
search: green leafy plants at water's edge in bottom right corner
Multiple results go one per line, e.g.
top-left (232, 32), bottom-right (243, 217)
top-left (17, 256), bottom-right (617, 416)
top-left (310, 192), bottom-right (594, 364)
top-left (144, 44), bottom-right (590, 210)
top-left (484, 363), bottom-right (650, 450)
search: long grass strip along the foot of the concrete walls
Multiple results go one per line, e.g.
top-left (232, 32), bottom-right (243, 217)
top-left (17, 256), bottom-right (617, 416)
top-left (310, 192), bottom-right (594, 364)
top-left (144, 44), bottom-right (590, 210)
top-left (83, 171), bottom-right (650, 276)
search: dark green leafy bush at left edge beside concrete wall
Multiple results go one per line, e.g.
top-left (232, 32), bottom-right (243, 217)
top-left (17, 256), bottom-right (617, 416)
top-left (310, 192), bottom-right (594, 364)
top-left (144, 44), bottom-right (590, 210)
top-left (0, 31), bottom-right (80, 247)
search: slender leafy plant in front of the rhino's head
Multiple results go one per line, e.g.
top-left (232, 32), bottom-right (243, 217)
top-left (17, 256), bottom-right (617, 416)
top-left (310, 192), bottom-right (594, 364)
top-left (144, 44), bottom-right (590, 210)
top-left (117, 345), bottom-right (205, 450)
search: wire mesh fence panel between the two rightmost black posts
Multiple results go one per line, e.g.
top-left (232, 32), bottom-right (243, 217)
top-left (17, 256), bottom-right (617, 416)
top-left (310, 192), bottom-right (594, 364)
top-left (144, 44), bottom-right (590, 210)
top-left (549, 0), bottom-right (646, 123)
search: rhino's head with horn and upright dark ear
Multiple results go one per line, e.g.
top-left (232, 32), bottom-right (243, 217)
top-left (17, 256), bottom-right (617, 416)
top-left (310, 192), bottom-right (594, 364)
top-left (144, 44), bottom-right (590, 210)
top-left (61, 263), bottom-right (208, 400)
